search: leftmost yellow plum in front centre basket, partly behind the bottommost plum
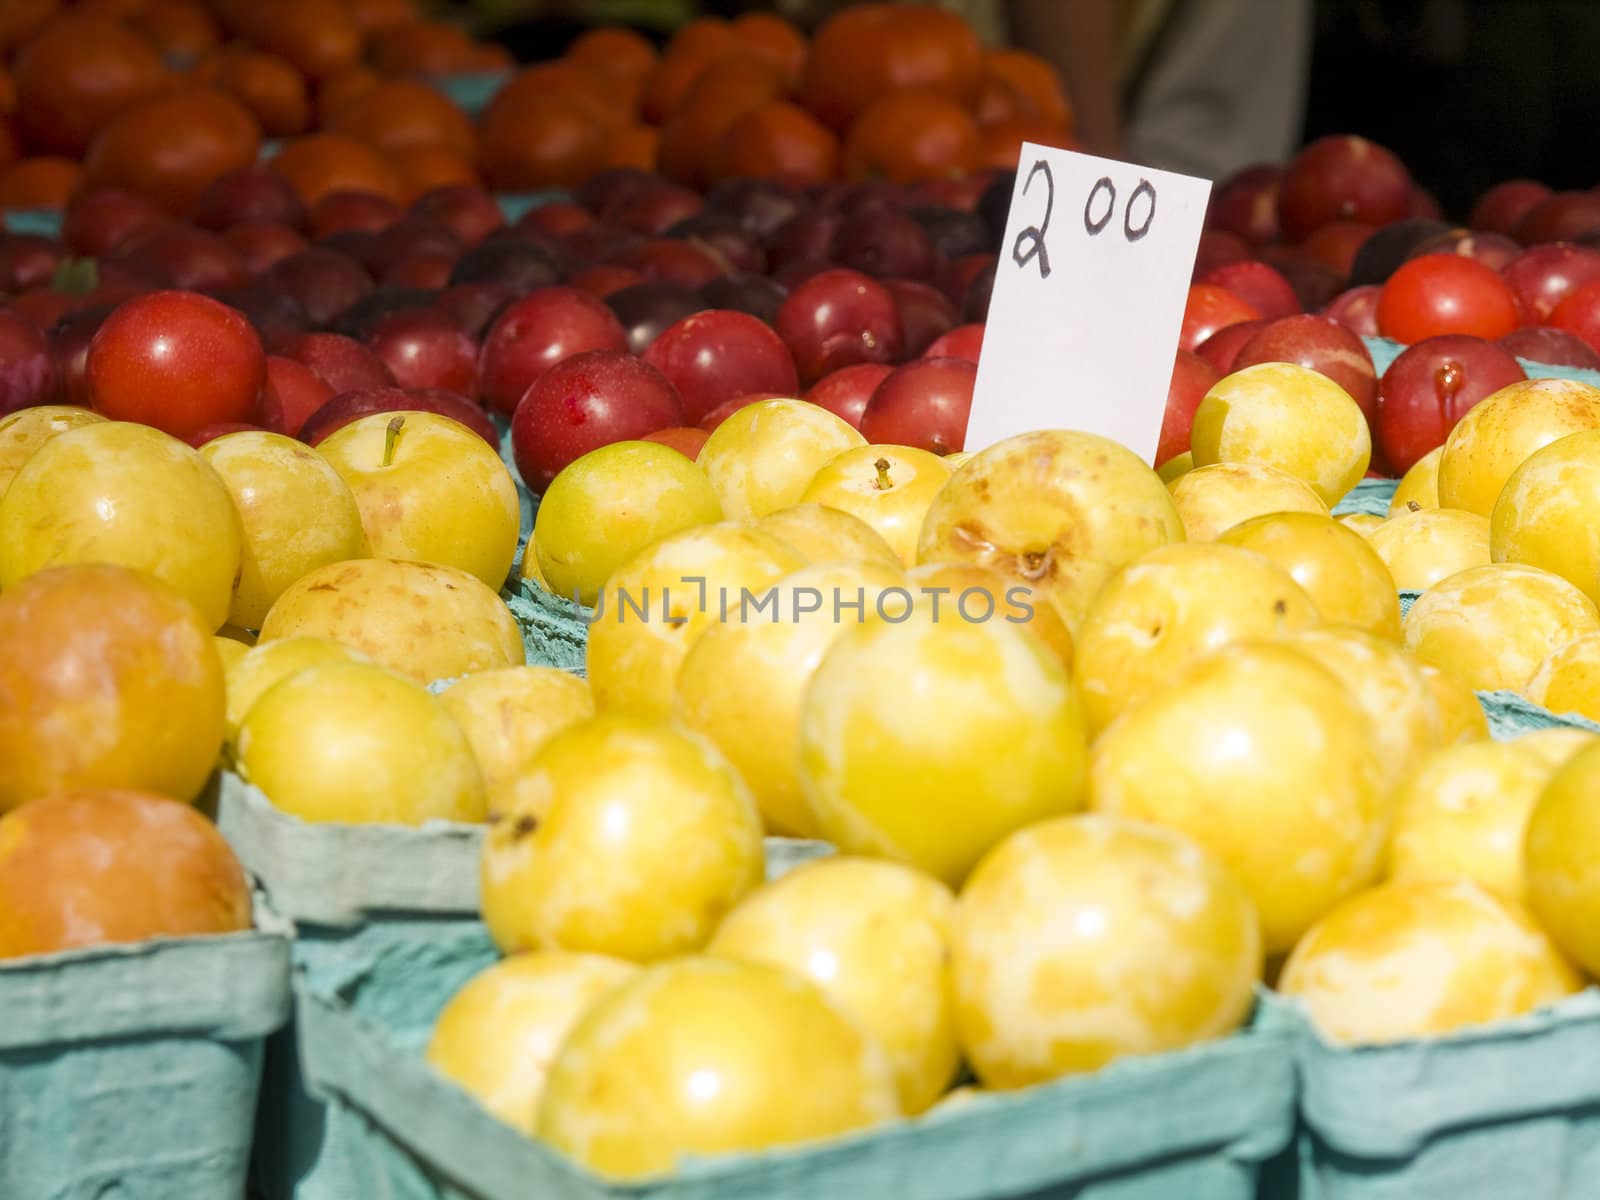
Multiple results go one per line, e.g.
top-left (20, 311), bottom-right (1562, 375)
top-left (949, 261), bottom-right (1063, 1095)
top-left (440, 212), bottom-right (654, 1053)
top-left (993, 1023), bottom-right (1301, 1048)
top-left (427, 950), bottom-right (638, 1136)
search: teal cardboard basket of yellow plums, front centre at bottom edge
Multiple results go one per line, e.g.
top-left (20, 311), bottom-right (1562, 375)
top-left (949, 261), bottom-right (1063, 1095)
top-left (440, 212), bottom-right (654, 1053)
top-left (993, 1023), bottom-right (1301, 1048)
top-left (296, 931), bottom-right (1294, 1200)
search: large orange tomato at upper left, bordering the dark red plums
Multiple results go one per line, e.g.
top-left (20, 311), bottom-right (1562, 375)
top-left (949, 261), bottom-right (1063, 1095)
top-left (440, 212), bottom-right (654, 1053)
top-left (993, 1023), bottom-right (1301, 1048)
top-left (83, 86), bottom-right (261, 216)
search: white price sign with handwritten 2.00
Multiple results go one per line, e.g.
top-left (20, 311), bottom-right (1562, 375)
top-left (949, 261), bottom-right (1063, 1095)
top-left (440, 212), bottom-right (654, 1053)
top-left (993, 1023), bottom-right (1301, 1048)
top-left (966, 142), bottom-right (1211, 462)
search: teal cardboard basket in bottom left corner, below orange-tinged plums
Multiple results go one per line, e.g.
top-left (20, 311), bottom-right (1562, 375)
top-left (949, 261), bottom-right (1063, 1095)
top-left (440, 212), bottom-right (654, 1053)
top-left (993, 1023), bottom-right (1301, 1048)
top-left (0, 901), bottom-right (290, 1200)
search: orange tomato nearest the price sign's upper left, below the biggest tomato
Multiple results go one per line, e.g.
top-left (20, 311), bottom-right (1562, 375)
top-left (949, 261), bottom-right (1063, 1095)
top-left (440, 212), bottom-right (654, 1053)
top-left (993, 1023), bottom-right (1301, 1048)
top-left (843, 90), bottom-right (979, 182)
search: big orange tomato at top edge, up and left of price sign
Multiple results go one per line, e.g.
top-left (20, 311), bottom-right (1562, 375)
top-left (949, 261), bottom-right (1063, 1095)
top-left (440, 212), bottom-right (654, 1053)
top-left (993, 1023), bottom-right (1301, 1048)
top-left (800, 3), bottom-right (982, 130)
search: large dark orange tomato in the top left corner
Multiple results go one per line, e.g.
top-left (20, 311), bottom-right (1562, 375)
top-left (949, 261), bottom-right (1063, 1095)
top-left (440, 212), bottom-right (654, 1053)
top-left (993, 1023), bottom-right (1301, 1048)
top-left (14, 16), bottom-right (166, 157)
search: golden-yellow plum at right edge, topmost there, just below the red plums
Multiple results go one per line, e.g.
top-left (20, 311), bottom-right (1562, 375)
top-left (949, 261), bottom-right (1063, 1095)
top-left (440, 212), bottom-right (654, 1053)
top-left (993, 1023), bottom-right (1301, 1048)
top-left (1438, 379), bottom-right (1600, 517)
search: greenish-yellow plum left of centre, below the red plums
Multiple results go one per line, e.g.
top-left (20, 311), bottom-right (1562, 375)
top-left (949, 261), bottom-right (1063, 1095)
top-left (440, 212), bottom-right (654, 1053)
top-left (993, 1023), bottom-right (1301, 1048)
top-left (533, 442), bottom-right (722, 605)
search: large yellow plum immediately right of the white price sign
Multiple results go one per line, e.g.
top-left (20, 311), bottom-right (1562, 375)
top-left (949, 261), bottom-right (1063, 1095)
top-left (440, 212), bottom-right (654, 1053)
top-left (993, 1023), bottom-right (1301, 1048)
top-left (1189, 363), bottom-right (1373, 504)
